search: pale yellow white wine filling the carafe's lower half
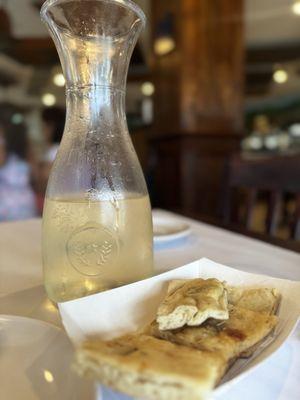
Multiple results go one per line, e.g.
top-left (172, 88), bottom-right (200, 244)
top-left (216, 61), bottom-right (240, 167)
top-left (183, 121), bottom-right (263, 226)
top-left (43, 195), bottom-right (153, 302)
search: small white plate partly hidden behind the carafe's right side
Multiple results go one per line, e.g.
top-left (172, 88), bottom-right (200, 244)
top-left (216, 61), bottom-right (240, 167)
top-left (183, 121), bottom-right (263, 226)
top-left (153, 215), bottom-right (191, 243)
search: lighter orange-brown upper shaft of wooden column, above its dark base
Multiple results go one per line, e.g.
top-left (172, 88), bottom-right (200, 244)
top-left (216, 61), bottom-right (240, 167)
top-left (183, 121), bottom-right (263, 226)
top-left (153, 0), bottom-right (244, 133)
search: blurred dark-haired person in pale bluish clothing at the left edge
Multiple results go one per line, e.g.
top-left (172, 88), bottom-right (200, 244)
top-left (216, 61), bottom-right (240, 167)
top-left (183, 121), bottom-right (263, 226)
top-left (0, 118), bottom-right (37, 221)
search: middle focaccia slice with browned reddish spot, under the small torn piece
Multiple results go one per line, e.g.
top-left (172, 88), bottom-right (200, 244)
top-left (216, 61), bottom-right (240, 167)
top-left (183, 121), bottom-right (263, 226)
top-left (146, 306), bottom-right (278, 363)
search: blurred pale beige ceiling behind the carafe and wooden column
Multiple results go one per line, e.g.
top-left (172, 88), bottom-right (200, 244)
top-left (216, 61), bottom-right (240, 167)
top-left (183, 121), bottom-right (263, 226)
top-left (4, 0), bottom-right (300, 46)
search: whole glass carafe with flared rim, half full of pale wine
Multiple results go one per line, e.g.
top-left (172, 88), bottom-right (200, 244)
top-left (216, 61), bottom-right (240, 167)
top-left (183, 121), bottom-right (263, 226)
top-left (41, 0), bottom-right (153, 302)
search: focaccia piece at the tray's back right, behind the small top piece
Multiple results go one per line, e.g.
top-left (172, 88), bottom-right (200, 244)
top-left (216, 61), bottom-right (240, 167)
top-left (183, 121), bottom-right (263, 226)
top-left (228, 287), bottom-right (281, 315)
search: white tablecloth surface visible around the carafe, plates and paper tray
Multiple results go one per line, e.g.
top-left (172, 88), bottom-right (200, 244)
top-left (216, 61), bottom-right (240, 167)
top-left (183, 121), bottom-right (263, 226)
top-left (0, 210), bottom-right (300, 400)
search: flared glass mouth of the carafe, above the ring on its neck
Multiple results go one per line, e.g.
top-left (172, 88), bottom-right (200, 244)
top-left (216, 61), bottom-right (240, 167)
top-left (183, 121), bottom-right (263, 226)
top-left (41, 0), bottom-right (145, 90)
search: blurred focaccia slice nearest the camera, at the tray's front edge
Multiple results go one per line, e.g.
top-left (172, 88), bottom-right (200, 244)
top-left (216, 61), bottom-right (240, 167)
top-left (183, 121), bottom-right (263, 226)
top-left (75, 334), bottom-right (227, 400)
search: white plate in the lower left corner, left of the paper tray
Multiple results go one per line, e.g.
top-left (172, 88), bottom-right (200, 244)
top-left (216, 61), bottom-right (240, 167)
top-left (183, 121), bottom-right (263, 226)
top-left (0, 315), bottom-right (95, 400)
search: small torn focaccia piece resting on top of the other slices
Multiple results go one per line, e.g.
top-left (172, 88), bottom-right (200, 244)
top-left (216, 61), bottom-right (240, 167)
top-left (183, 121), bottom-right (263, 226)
top-left (156, 279), bottom-right (228, 330)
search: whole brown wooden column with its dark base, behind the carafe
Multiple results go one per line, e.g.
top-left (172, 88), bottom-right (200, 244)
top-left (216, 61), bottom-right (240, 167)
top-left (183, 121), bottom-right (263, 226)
top-left (152, 0), bottom-right (244, 216)
